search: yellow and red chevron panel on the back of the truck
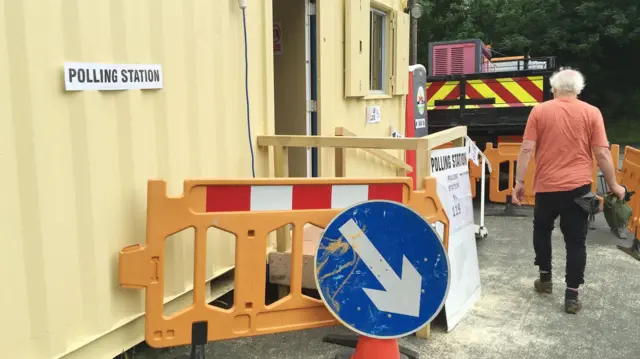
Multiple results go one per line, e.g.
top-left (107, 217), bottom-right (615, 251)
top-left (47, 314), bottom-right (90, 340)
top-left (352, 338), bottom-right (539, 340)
top-left (427, 76), bottom-right (544, 110)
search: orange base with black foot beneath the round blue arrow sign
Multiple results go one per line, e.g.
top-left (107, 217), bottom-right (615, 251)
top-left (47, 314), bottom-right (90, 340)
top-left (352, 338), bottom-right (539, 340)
top-left (322, 334), bottom-right (420, 359)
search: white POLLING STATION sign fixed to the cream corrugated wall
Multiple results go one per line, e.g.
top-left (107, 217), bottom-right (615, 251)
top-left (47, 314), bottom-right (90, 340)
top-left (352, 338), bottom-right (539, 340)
top-left (64, 62), bottom-right (163, 91)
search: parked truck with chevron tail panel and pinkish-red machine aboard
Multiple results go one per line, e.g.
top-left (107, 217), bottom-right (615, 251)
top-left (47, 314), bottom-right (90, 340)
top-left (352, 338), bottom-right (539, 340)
top-left (426, 39), bottom-right (556, 150)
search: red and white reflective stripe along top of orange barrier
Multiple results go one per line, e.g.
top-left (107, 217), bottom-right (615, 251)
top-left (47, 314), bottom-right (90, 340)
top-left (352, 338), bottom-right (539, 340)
top-left (206, 183), bottom-right (404, 212)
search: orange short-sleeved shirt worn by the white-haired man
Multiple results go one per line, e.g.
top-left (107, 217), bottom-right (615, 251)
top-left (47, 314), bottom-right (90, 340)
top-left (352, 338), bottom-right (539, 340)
top-left (524, 98), bottom-right (609, 193)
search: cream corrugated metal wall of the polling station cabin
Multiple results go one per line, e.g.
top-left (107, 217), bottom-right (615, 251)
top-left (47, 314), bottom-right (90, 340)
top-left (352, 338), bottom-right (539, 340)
top-left (0, 0), bottom-right (273, 359)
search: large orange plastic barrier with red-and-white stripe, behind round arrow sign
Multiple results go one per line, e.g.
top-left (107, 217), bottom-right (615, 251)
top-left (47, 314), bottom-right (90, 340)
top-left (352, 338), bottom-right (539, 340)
top-left (119, 178), bottom-right (449, 348)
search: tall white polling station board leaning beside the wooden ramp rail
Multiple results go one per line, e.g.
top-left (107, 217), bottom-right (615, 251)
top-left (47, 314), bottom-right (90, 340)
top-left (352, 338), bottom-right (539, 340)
top-left (430, 146), bottom-right (481, 331)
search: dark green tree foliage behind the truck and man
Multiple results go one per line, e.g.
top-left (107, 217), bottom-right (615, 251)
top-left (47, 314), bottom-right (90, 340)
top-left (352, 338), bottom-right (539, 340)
top-left (418, 0), bottom-right (640, 129)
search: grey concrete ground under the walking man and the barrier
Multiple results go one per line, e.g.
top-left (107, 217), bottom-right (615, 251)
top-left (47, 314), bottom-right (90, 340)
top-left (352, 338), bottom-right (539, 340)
top-left (128, 202), bottom-right (640, 359)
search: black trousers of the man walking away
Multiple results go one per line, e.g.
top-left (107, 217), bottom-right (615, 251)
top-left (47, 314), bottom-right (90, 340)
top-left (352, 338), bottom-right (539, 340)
top-left (533, 183), bottom-right (591, 288)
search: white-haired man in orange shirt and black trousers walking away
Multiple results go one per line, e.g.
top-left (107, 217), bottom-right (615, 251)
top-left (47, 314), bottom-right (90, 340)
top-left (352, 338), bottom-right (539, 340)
top-left (513, 68), bottom-right (625, 314)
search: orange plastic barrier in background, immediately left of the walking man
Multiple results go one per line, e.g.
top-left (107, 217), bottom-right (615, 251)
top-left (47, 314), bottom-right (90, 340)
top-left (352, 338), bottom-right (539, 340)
top-left (484, 143), bottom-right (535, 206)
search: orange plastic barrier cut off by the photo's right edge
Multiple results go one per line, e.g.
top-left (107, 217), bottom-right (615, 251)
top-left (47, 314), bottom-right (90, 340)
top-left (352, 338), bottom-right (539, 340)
top-left (619, 146), bottom-right (640, 236)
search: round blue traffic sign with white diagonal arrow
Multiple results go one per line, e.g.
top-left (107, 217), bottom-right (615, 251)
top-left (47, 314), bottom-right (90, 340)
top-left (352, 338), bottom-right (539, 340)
top-left (315, 200), bottom-right (450, 339)
